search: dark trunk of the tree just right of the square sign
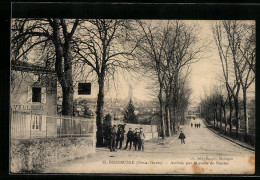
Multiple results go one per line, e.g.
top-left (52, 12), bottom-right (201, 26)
top-left (96, 72), bottom-right (105, 146)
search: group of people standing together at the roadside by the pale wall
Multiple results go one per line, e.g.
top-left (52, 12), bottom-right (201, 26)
top-left (108, 125), bottom-right (145, 152)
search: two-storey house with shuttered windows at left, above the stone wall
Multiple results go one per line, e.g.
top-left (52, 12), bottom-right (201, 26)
top-left (10, 62), bottom-right (57, 139)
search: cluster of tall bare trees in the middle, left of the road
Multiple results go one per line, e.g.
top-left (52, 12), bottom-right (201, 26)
top-left (133, 21), bottom-right (203, 138)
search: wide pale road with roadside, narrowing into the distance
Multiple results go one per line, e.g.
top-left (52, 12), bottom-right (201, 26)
top-left (43, 118), bottom-right (255, 174)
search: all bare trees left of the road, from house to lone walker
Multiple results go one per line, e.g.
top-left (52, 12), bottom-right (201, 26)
top-left (11, 18), bottom-right (201, 145)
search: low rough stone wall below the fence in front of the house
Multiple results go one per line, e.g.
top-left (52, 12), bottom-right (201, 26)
top-left (10, 137), bottom-right (95, 173)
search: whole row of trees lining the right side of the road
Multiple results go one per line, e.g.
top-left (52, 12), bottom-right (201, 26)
top-left (201, 21), bottom-right (256, 141)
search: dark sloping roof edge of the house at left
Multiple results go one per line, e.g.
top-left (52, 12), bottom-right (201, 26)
top-left (11, 61), bottom-right (56, 74)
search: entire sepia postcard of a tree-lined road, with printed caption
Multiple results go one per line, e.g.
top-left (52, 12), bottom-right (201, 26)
top-left (9, 18), bottom-right (256, 175)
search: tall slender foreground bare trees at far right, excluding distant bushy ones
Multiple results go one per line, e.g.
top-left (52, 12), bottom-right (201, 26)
top-left (212, 21), bottom-right (255, 141)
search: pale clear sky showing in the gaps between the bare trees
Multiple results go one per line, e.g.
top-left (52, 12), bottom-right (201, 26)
top-left (72, 20), bottom-right (254, 104)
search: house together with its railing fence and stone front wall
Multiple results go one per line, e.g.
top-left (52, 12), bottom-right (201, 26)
top-left (10, 62), bottom-right (96, 173)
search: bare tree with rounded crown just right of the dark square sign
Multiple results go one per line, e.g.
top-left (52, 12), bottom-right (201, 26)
top-left (74, 19), bottom-right (134, 146)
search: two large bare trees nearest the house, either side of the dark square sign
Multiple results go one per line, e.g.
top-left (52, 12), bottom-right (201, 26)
top-left (11, 18), bottom-right (135, 145)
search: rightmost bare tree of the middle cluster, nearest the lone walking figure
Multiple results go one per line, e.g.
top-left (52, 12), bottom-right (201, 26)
top-left (164, 21), bottom-right (205, 132)
